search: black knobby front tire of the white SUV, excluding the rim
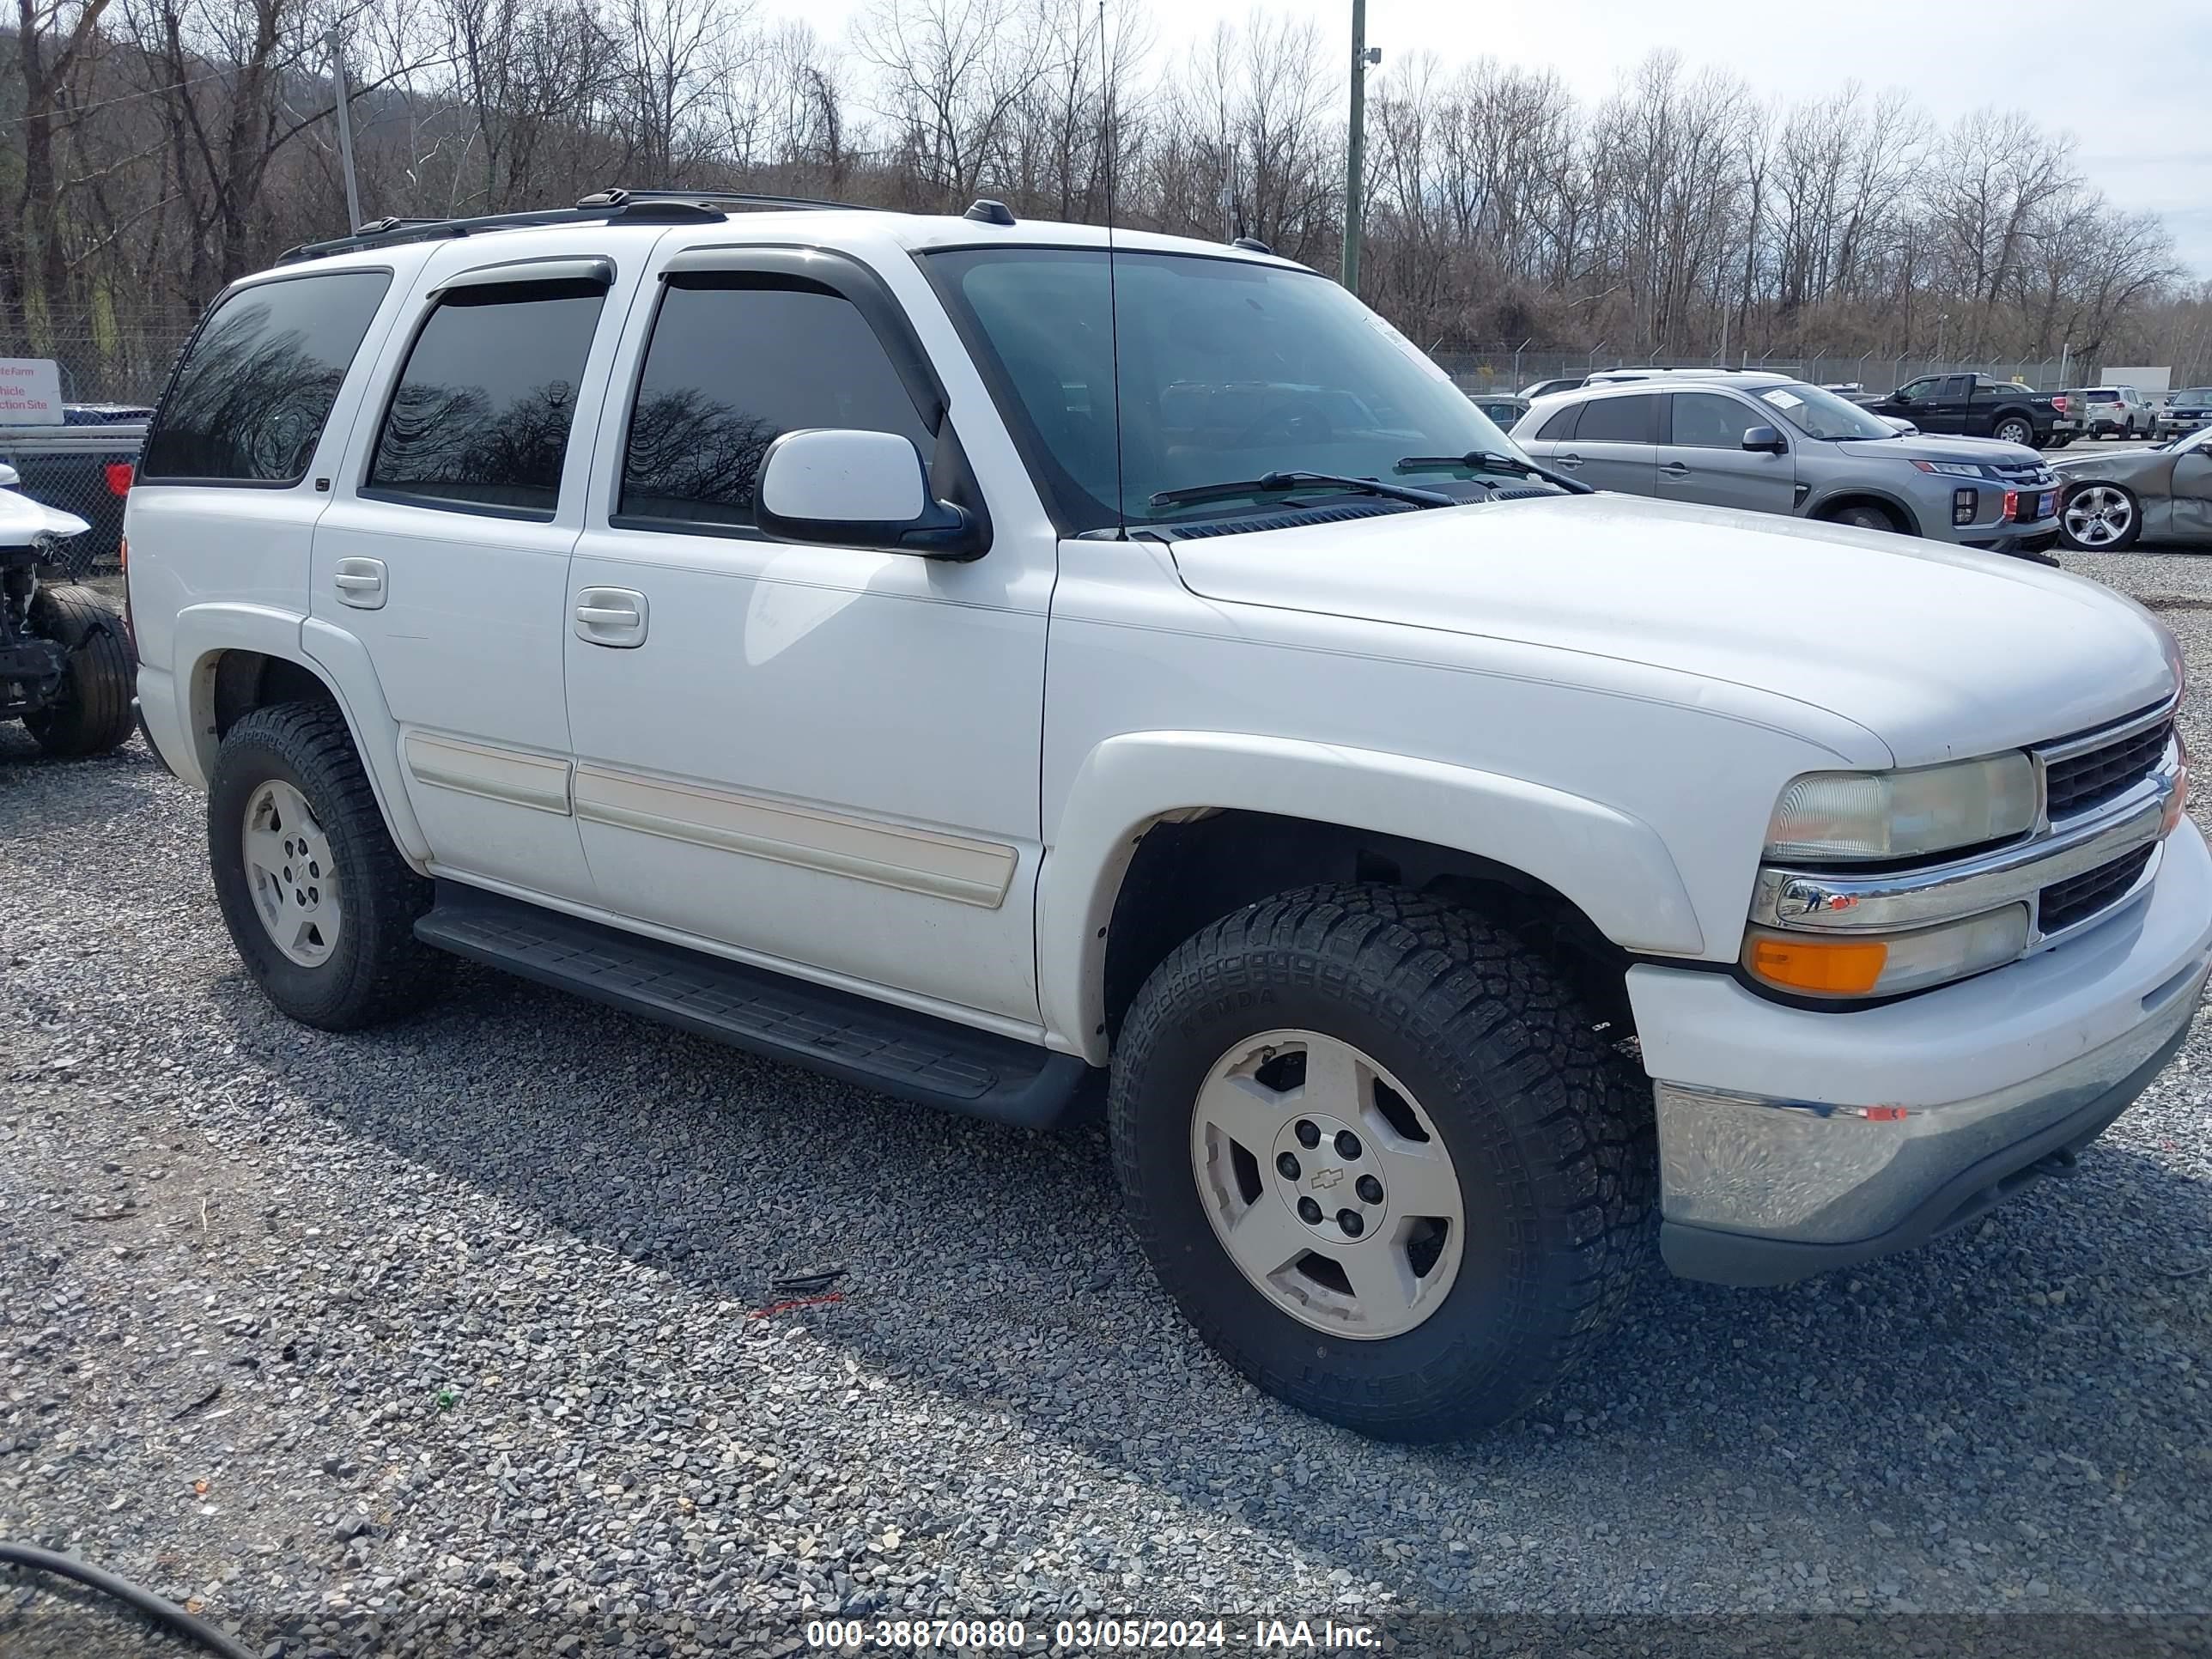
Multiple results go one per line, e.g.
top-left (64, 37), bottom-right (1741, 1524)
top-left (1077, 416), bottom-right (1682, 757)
top-left (1109, 884), bottom-right (1656, 1440)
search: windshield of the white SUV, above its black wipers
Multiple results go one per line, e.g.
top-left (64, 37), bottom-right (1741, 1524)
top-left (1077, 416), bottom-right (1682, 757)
top-left (927, 248), bottom-right (1522, 535)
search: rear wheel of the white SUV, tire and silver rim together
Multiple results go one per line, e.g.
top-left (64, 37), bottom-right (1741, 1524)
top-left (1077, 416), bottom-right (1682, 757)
top-left (208, 703), bottom-right (442, 1030)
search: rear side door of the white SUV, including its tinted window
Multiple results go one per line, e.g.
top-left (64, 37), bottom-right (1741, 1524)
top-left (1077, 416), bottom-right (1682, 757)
top-left (312, 243), bottom-right (635, 900)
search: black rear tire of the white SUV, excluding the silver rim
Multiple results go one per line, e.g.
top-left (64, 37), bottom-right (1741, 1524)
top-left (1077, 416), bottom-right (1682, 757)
top-left (208, 703), bottom-right (447, 1030)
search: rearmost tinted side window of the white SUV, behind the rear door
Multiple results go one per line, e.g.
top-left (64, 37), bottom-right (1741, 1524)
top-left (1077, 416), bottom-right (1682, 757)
top-left (139, 270), bottom-right (392, 484)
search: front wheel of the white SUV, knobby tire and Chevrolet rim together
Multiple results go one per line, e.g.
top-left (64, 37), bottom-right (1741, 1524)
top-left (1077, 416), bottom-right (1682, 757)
top-left (1109, 887), bottom-right (1656, 1440)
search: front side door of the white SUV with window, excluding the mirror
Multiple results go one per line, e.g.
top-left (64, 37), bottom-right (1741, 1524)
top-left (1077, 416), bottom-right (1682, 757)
top-left (564, 246), bottom-right (1057, 1026)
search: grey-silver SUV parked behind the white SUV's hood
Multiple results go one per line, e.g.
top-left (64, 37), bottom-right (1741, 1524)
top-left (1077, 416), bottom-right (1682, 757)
top-left (1513, 369), bottom-right (2059, 557)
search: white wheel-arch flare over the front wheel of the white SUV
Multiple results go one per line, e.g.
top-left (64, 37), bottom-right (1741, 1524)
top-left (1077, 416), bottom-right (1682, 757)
top-left (1037, 732), bottom-right (1705, 1064)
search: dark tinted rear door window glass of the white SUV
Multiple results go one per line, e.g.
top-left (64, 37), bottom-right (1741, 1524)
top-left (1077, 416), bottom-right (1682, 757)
top-left (362, 283), bottom-right (606, 518)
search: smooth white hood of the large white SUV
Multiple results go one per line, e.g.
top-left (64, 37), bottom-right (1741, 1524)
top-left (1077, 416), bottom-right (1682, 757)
top-left (1170, 495), bottom-right (2177, 765)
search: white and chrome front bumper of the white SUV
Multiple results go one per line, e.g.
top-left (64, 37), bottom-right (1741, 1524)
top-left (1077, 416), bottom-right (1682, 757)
top-left (1628, 821), bottom-right (2212, 1285)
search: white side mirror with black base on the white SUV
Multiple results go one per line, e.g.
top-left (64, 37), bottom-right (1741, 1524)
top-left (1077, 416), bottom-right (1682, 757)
top-left (752, 427), bottom-right (988, 560)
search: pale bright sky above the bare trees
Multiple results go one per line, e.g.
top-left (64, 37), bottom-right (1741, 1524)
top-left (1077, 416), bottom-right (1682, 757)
top-left (787, 0), bottom-right (2212, 276)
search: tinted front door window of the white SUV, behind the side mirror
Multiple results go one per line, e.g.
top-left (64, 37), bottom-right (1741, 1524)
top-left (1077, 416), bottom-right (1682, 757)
top-left (617, 276), bottom-right (931, 529)
